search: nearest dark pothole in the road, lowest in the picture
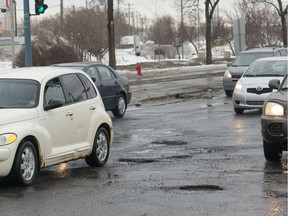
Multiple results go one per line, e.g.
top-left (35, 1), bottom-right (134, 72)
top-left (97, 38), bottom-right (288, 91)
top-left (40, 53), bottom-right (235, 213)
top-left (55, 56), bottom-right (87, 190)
top-left (161, 185), bottom-right (224, 192)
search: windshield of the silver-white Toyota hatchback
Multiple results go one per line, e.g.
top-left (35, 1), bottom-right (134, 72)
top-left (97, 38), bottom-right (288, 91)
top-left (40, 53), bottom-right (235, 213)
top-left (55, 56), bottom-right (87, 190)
top-left (243, 60), bottom-right (287, 77)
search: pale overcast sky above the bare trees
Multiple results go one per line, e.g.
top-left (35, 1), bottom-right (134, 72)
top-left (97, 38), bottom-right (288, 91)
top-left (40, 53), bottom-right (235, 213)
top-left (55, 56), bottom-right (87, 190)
top-left (14, 0), bottom-right (234, 19)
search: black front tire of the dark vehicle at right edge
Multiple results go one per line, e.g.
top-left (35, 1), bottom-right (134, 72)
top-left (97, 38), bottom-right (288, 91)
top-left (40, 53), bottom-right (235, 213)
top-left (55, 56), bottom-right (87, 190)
top-left (263, 140), bottom-right (283, 162)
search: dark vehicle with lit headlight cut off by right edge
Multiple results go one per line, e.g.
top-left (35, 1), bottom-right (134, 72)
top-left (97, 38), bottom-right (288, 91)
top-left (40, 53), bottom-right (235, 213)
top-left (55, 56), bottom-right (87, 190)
top-left (261, 75), bottom-right (288, 161)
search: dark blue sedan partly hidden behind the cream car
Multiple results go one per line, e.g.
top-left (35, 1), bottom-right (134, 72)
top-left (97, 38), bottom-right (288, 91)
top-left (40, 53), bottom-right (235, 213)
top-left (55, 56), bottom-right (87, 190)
top-left (53, 62), bottom-right (132, 117)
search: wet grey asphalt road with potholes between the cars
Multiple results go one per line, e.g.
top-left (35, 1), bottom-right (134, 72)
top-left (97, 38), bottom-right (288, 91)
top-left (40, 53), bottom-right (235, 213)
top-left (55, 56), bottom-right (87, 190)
top-left (0, 65), bottom-right (287, 216)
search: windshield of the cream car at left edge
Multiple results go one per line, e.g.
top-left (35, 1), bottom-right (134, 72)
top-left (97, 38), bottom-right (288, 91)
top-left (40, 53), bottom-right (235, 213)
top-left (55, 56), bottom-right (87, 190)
top-left (0, 79), bottom-right (39, 109)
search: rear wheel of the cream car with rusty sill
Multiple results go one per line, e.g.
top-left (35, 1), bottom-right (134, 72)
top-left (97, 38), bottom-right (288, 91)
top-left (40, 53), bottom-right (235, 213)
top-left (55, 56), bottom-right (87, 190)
top-left (85, 127), bottom-right (110, 167)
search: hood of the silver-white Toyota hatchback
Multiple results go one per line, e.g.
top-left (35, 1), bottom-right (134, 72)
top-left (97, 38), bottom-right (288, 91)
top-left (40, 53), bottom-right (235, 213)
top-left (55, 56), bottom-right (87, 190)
top-left (240, 76), bottom-right (284, 88)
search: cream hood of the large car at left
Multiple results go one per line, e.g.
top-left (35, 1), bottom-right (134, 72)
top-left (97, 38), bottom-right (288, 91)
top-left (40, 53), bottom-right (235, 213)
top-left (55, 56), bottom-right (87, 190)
top-left (0, 108), bottom-right (38, 125)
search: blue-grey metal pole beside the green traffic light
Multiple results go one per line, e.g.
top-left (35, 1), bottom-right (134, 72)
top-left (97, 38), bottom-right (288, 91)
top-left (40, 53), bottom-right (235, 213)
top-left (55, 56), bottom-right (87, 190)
top-left (23, 0), bottom-right (32, 67)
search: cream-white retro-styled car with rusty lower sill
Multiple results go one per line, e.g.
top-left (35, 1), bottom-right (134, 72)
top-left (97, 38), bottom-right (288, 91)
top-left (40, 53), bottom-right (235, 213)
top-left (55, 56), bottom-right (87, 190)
top-left (0, 67), bottom-right (113, 186)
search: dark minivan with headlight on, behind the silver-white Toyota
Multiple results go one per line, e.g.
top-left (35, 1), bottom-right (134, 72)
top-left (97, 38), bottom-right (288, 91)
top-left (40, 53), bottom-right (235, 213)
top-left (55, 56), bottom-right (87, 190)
top-left (223, 47), bottom-right (287, 97)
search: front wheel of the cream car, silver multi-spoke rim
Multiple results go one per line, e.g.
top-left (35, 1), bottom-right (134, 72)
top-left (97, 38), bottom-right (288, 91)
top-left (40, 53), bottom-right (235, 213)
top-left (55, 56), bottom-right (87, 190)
top-left (10, 141), bottom-right (39, 186)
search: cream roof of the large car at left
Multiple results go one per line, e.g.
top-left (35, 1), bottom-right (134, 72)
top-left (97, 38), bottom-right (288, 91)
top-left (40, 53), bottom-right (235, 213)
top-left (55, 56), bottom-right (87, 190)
top-left (0, 66), bottom-right (85, 82)
